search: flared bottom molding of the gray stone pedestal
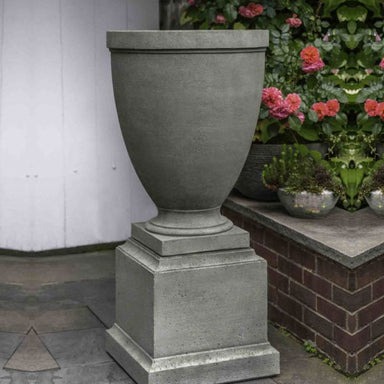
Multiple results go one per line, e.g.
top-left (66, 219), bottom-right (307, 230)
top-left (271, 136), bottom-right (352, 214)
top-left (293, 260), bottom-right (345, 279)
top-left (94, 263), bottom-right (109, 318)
top-left (106, 324), bottom-right (280, 384)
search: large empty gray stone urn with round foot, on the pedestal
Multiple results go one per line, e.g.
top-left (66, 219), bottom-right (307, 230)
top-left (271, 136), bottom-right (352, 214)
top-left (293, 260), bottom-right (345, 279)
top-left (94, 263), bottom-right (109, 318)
top-left (108, 30), bottom-right (268, 235)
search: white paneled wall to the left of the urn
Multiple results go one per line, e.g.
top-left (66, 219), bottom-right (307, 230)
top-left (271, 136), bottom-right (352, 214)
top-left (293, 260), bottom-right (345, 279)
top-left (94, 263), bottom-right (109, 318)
top-left (0, 0), bottom-right (158, 251)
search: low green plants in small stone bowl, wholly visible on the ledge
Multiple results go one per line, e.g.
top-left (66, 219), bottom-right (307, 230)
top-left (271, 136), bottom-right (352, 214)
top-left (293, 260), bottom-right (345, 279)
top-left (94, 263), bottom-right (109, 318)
top-left (262, 145), bottom-right (344, 218)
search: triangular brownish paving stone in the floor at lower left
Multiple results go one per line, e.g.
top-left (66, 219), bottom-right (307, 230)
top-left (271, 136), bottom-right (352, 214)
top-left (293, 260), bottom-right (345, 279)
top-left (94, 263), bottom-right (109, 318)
top-left (4, 328), bottom-right (59, 372)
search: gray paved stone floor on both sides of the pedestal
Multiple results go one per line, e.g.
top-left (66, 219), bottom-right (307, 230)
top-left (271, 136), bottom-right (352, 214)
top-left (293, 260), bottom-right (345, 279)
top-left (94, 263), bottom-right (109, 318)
top-left (0, 251), bottom-right (384, 384)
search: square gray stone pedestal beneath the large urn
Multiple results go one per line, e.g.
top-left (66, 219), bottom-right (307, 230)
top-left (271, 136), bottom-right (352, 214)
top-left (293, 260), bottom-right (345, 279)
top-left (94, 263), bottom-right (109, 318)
top-left (106, 224), bottom-right (279, 384)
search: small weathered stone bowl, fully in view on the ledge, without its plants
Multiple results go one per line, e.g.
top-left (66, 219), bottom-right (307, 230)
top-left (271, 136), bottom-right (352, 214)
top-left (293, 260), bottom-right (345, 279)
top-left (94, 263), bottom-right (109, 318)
top-left (277, 188), bottom-right (339, 219)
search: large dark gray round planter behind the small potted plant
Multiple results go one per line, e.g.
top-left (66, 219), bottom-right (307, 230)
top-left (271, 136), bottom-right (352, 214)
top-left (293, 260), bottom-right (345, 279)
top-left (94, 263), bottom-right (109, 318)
top-left (235, 143), bottom-right (328, 201)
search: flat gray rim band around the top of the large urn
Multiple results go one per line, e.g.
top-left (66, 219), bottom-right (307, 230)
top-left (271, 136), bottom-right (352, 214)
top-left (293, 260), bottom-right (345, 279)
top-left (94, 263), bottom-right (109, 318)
top-left (107, 30), bottom-right (269, 51)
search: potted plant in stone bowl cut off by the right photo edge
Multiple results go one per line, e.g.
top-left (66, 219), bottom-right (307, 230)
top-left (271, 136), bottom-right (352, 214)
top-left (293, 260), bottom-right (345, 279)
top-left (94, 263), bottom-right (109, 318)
top-left (359, 160), bottom-right (384, 215)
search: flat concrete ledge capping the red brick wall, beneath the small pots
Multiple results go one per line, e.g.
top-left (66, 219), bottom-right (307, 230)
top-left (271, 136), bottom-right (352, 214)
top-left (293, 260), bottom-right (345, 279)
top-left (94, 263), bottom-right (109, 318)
top-left (224, 194), bottom-right (384, 269)
